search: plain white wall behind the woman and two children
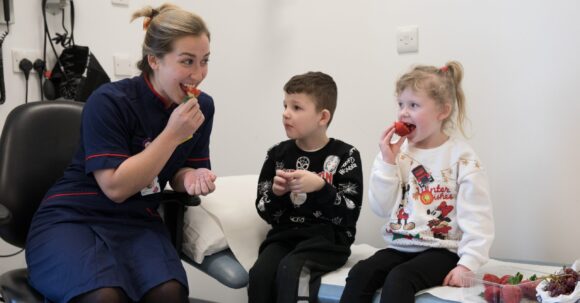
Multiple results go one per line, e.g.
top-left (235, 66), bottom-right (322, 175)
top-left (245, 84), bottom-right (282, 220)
top-left (0, 0), bottom-right (580, 302)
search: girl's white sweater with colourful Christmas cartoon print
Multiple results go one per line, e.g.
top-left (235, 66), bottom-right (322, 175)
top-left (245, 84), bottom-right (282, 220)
top-left (369, 138), bottom-right (494, 271)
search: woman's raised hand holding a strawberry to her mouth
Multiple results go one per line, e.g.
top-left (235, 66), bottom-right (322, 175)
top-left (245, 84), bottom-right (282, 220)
top-left (165, 98), bottom-right (205, 143)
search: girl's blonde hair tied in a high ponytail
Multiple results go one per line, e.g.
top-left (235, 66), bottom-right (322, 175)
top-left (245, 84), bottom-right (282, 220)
top-left (396, 61), bottom-right (467, 137)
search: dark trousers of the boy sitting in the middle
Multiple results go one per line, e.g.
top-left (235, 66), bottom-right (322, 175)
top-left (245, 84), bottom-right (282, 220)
top-left (248, 224), bottom-right (350, 303)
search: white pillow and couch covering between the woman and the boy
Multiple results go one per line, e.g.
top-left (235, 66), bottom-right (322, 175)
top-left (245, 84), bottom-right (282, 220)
top-left (182, 175), bottom-right (270, 270)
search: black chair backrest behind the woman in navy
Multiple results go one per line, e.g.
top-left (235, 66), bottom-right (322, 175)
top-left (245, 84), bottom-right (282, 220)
top-left (0, 101), bottom-right (83, 247)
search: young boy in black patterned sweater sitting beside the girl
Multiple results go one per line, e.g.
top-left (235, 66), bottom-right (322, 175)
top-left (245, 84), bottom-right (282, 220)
top-left (248, 72), bottom-right (363, 303)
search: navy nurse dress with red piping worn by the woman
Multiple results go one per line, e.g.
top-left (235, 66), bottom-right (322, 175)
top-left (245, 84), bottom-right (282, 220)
top-left (26, 77), bottom-right (214, 302)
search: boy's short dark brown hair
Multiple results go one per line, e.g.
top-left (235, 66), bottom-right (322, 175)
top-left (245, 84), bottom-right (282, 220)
top-left (284, 72), bottom-right (337, 125)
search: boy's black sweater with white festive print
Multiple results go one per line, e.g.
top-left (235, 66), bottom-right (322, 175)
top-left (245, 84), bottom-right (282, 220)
top-left (256, 138), bottom-right (363, 243)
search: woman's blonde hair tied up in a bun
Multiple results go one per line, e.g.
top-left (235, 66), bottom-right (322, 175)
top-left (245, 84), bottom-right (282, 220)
top-left (131, 3), bottom-right (210, 76)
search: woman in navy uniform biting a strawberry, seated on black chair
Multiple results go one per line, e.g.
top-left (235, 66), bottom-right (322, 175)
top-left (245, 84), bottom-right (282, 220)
top-left (26, 4), bottom-right (216, 303)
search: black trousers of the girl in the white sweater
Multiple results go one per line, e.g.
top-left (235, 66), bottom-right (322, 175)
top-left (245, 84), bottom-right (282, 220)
top-left (340, 248), bottom-right (459, 303)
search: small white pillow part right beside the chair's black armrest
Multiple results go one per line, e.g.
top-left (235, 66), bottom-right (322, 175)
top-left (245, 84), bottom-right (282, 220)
top-left (181, 206), bottom-right (228, 263)
